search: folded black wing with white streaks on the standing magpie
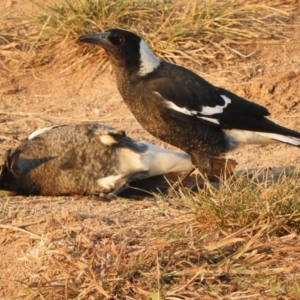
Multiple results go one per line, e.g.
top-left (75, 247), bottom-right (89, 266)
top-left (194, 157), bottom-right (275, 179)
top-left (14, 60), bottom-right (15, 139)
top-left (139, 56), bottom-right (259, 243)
top-left (147, 69), bottom-right (270, 130)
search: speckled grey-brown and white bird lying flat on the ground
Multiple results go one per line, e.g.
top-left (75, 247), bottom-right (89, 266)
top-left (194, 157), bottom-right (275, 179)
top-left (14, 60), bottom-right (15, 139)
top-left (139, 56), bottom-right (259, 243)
top-left (0, 123), bottom-right (192, 200)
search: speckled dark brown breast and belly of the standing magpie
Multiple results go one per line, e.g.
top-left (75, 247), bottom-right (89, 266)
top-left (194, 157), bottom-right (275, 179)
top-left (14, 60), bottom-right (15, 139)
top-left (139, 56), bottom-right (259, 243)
top-left (118, 80), bottom-right (229, 155)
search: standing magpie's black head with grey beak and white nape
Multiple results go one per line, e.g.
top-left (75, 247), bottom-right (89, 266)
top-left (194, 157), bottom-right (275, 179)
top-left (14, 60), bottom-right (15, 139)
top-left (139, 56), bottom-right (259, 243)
top-left (79, 29), bottom-right (160, 77)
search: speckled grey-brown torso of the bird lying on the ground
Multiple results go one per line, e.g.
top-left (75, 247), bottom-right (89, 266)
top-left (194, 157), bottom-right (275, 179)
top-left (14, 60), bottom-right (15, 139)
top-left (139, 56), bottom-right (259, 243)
top-left (3, 124), bottom-right (117, 195)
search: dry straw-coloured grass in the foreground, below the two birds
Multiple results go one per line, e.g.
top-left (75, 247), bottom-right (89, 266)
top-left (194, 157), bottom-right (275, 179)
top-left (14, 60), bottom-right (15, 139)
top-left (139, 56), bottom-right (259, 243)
top-left (5, 175), bottom-right (300, 300)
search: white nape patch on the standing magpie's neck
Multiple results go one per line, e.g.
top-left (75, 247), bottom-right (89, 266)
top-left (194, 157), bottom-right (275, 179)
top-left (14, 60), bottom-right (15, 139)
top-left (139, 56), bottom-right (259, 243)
top-left (138, 40), bottom-right (160, 76)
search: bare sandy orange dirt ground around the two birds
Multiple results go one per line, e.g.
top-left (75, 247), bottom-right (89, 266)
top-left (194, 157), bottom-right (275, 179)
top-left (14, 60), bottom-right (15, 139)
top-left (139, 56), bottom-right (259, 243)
top-left (0, 1), bottom-right (300, 299)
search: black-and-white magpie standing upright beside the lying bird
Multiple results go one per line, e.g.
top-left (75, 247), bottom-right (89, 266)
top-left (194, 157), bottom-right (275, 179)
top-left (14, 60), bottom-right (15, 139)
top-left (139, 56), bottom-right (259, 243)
top-left (79, 29), bottom-right (300, 172)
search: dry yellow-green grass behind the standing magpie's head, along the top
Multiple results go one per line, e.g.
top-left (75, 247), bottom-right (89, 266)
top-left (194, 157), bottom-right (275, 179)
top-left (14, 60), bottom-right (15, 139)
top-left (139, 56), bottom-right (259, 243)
top-left (0, 0), bottom-right (297, 79)
